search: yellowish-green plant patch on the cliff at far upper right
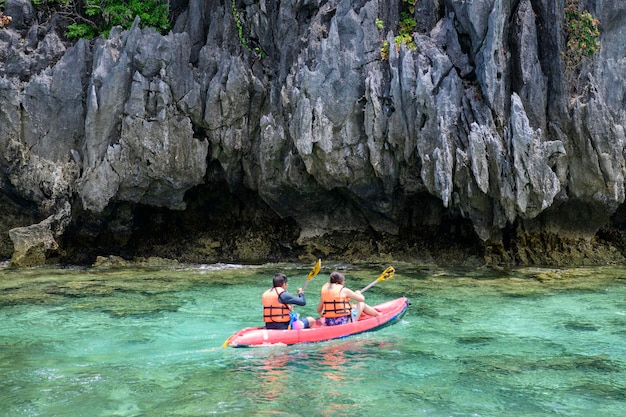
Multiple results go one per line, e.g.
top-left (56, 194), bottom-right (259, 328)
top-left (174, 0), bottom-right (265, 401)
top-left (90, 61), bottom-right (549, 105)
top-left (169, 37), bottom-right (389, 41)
top-left (563, 0), bottom-right (601, 68)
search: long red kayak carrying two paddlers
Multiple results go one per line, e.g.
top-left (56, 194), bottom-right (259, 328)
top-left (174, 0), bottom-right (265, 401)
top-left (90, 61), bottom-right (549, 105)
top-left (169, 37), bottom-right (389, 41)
top-left (223, 297), bottom-right (410, 348)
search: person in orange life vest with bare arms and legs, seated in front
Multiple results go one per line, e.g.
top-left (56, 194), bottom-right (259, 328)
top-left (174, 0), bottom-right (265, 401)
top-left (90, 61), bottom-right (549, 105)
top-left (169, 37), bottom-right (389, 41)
top-left (317, 271), bottom-right (380, 326)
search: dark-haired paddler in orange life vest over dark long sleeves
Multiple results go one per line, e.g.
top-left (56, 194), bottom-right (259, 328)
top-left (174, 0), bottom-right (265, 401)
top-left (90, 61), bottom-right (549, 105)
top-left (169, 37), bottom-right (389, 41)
top-left (262, 273), bottom-right (313, 330)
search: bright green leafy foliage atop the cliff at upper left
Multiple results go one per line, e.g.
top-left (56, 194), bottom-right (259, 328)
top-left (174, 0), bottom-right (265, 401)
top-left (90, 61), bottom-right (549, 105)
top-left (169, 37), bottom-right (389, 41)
top-left (33, 0), bottom-right (171, 39)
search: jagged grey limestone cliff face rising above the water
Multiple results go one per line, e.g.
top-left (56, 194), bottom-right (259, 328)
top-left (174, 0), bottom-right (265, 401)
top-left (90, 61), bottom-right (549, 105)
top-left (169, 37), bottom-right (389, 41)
top-left (0, 0), bottom-right (626, 265)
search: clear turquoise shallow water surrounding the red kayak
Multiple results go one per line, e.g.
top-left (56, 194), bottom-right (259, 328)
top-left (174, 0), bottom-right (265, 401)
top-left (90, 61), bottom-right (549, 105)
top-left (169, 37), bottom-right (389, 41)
top-left (0, 265), bottom-right (626, 417)
